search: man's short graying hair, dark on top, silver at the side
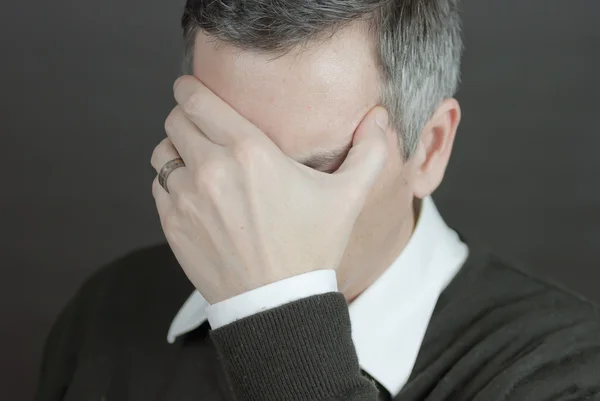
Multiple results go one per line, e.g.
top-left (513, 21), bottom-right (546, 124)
top-left (182, 0), bottom-right (463, 160)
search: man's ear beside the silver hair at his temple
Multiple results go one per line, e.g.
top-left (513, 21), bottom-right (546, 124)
top-left (413, 98), bottom-right (461, 199)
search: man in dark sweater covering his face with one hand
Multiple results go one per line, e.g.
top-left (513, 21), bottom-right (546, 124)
top-left (37, 0), bottom-right (600, 401)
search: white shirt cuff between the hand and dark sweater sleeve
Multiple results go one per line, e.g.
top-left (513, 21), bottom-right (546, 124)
top-left (206, 269), bottom-right (338, 330)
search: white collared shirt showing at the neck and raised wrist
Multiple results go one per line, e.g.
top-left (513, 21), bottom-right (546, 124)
top-left (167, 197), bottom-right (469, 397)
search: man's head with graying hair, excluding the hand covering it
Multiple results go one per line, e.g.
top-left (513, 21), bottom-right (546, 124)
top-left (182, 0), bottom-right (462, 296)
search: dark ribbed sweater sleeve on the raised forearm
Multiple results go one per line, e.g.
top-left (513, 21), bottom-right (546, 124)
top-left (210, 292), bottom-right (378, 401)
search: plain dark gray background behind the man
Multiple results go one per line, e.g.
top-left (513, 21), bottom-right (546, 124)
top-left (0, 0), bottom-right (600, 400)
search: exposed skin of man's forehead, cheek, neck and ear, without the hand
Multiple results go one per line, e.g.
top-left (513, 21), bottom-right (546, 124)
top-left (193, 23), bottom-right (461, 302)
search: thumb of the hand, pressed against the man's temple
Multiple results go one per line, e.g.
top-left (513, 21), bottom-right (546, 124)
top-left (333, 106), bottom-right (389, 196)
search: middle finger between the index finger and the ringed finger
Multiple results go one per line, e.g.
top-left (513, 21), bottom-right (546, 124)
top-left (165, 105), bottom-right (223, 167)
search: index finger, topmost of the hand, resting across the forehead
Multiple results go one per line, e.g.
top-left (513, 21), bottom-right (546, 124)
top-left (173, 75), bottom-right (261, 146)
